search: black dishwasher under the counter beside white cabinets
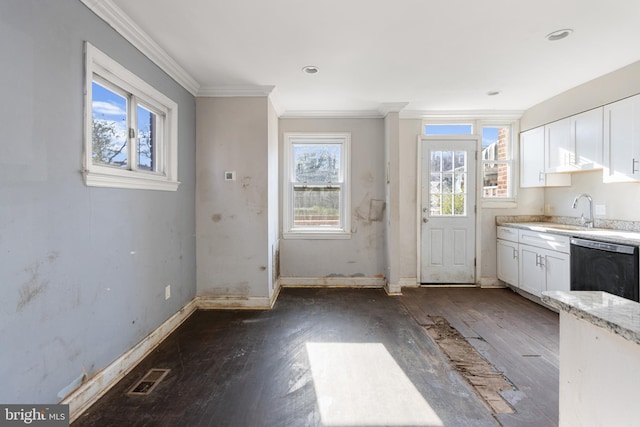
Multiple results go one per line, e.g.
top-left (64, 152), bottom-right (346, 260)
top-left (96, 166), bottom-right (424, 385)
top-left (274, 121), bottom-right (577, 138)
top-left (571, 238), bottom-right (640, 301)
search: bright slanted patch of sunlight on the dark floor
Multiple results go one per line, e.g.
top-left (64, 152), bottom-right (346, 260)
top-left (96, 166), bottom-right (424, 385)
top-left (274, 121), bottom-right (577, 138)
top-left (306, 343), bottom-right (443, 427)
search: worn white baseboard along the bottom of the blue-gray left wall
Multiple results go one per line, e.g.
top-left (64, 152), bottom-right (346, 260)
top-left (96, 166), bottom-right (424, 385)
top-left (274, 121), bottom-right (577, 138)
top-left (60, 298), bottom-right (197, 422)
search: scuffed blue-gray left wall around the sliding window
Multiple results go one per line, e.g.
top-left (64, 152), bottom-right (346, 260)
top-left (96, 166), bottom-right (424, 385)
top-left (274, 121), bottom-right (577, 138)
top-left (0, 0), bottom-right (196, 403)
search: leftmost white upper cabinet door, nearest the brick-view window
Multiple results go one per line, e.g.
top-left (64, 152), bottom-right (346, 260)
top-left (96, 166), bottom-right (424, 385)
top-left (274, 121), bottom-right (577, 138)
top-left (520, 127), bottom-right (545, 187)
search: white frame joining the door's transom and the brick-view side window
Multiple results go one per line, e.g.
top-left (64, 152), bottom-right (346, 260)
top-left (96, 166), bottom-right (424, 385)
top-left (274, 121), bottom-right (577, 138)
top-left (422, 115), bottom-right (519, 208)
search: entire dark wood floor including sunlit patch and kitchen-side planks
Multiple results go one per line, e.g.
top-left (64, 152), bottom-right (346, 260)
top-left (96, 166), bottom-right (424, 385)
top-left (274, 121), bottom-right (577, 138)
top-left (74, 288), bottom-right (558, 427)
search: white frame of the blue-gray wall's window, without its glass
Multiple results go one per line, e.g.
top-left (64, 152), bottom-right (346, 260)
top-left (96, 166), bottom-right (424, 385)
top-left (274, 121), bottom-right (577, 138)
top-left (83, 42), bottom-right (180, 191)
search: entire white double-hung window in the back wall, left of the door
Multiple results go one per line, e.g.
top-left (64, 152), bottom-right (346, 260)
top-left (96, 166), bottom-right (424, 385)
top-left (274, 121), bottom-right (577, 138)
top-left (283, 133), bottom-right (351, 239)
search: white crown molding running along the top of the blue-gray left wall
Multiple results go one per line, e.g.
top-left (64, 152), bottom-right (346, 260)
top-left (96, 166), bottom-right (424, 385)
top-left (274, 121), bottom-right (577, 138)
top-left (80, 0), bottom-right (200, 95)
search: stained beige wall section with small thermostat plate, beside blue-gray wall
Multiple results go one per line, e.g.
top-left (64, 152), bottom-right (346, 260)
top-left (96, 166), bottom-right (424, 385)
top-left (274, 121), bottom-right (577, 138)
top-left (196, 97), bottom-right (277, 298)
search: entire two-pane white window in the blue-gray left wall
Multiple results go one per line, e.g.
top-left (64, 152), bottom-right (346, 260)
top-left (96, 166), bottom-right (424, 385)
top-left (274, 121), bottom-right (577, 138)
top-left (83, 43), bottom-right (179, 191)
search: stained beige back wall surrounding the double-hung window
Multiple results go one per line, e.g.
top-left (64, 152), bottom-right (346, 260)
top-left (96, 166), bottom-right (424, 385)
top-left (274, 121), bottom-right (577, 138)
top-left (279, 119), bottom-right (386, 278)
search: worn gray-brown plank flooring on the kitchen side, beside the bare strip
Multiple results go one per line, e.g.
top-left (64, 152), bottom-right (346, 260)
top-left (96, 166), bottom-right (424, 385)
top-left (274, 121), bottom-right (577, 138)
top-left (400, 288), bottom-right (559, 427)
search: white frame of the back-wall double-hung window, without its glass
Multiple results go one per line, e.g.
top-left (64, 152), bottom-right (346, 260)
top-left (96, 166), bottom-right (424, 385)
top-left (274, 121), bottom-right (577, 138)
top-left (282, 132), bottom-right (351, 239)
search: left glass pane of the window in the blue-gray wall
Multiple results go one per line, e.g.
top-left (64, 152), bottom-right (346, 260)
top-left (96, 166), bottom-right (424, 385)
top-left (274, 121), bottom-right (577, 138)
top-left (91, 82), bottom-right (128, 168)
